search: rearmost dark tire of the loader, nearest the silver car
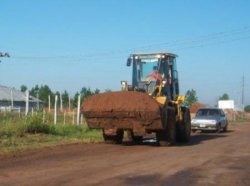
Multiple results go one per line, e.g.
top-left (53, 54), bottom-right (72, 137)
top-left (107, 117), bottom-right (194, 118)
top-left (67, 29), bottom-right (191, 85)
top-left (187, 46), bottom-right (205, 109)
top-left (176, 107), bottom-right (191, 143)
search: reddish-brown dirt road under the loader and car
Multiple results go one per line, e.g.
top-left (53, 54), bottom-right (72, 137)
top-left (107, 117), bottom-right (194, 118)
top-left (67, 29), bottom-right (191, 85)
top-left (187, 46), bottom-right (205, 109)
top-left (0, 123), bottom-right (250, 186)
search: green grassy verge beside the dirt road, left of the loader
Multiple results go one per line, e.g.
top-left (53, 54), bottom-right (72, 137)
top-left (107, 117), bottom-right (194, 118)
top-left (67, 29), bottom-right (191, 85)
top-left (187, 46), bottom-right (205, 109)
top-left (0, 114), bottom-right (102, 154)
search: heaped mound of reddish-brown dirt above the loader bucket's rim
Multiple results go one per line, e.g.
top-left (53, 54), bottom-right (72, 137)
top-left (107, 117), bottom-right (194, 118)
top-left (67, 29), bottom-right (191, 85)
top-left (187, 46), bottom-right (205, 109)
top-left (82, 91), bottom-right (159, 116)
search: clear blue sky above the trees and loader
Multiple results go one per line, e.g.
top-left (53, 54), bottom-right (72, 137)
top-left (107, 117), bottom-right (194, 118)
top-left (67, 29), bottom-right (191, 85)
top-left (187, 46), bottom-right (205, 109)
top-left (0, 0), bottom-right (250, 105)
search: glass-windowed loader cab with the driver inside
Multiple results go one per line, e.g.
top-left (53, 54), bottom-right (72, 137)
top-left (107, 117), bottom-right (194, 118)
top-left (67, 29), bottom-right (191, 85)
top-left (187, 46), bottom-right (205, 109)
top-left (127, 53), bottom-right (179, 100)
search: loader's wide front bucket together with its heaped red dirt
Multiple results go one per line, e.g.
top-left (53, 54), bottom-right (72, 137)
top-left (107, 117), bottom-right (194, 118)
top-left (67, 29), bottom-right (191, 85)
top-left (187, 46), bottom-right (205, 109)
top-left (81, 91), bottom-right (162, 132)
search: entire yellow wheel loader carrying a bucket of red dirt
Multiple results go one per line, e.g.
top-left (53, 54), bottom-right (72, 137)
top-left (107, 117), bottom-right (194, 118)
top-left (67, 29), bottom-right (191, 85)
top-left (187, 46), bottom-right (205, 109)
top-left (81, 52), bottom-right (191, 146)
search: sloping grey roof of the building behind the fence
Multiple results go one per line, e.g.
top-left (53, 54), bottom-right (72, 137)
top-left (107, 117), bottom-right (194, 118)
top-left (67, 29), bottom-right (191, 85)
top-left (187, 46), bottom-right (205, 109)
top-left (0, 85), bottom-right (41, 102)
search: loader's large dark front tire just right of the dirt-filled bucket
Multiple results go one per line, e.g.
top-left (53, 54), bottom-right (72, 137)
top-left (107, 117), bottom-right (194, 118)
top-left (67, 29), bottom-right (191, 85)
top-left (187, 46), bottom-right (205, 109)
top-left (156, 107), bottom-right (176, 146)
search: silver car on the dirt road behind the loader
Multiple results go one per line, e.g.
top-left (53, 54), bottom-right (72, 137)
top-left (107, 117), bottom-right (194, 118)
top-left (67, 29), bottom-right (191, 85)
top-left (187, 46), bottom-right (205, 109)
top-left (191, 108), bottom-right (228, 132)
